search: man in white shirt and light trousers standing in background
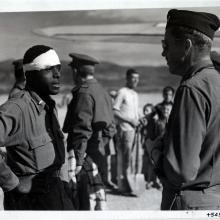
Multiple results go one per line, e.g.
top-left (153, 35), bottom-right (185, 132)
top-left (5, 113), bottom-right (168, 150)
top-left (113, 69), bottom-right (139, 195)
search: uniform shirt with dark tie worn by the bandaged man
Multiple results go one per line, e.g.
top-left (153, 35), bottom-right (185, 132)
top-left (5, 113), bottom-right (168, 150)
top-left (0, 90), bottom-right (65, 176)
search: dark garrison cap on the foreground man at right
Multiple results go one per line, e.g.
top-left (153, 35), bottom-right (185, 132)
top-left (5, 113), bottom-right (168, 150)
top-left (166, 9), bottom-right (220, 39)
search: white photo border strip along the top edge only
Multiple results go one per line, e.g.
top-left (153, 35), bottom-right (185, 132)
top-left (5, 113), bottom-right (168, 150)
top-left (0, 0), bottom-right (220, 12)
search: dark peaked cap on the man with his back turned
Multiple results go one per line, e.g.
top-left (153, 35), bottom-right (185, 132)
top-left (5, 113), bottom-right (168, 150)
top-left (69, 53), bottom-right (99, 66)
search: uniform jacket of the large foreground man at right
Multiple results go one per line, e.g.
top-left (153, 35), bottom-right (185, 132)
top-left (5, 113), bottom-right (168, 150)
top-left (163, 62), bottom-right (220, 189)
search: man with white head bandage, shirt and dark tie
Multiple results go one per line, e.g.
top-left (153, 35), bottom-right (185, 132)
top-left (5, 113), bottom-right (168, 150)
top-left (0, 45), bottom-right (73, 210)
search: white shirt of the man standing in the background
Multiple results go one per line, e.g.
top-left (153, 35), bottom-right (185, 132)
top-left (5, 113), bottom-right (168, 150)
top-left (113, 87), bottom-right (138, 131)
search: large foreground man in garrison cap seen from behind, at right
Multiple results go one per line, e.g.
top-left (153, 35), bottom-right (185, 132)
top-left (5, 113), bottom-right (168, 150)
top-left (151, 9), bottom-right (220, 210)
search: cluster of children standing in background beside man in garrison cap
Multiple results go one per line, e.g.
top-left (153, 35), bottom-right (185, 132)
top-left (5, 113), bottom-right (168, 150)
top-left (140, 86), bottom-right (175, 189)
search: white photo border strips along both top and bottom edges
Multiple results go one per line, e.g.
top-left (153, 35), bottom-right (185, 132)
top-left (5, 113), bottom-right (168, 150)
top-left (0, 0), bottom-right (220, 220)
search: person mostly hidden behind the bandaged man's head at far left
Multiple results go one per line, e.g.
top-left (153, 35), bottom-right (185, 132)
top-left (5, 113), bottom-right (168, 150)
top-left (9, 59), bottom-right (25, 99)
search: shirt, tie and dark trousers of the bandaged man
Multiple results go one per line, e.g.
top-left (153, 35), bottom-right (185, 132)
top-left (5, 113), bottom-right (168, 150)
top-left (0, 90), bottom-right (73, 210)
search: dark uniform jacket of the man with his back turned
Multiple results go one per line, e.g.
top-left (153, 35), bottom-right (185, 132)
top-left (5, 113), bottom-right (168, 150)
top-left (63, 79), bottom-right (115, 165)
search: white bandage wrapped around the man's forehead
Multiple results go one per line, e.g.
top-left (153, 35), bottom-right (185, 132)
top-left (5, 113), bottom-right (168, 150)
top-left (23, 49), bottom-right (60, 72)
